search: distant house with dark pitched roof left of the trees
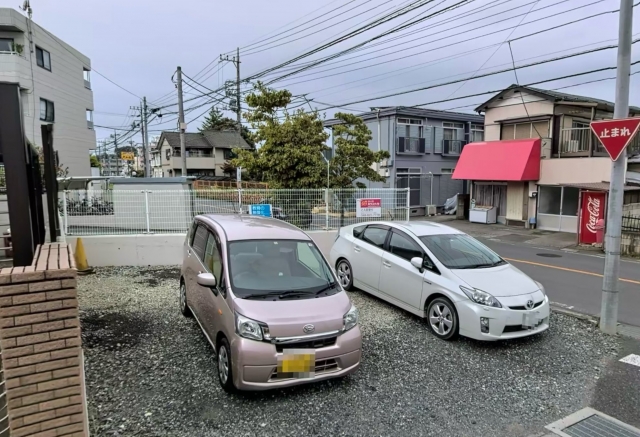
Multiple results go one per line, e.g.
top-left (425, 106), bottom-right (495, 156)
top-left (151, 131), bottom-right (252, 177)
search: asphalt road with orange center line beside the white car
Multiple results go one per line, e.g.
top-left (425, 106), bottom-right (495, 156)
top-left (480, 238), bottom-right (640, 326)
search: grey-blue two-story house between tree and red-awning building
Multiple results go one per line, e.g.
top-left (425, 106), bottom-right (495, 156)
top-left (324, 106), bottom-right (484, 215)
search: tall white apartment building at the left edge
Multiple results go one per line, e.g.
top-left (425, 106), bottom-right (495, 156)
top-left (0, 8), bottom-right (96, 176)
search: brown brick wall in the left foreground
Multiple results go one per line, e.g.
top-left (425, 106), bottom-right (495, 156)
top-left (0, 243), bottom-right (88, 437)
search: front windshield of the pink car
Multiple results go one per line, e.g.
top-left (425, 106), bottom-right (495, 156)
top-left (229, 240), bottom-right (340, 298)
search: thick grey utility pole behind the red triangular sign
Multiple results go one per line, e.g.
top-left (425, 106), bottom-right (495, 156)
top-left (600, 0), bottom-right (633, 334)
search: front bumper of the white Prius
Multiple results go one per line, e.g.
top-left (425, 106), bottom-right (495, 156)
top-left (456, 296), bottom-right (550, 341)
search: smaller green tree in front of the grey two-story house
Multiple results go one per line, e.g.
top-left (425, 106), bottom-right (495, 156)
top-left (329, 112), bottom-right (390, 188)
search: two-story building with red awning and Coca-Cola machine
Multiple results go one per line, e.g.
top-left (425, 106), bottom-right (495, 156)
top-left (453, 85), bottom-right (640, 242)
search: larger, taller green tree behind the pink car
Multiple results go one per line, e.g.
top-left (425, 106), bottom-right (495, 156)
top-left (232, 83), bottom-right (329, 188)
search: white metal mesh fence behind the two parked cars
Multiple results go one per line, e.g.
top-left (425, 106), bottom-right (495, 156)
top-left (58, 188), bottom-right (410, 235)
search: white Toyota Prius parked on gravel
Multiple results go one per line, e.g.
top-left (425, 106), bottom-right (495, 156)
top-left (331, 221), bottom-right (549, 340)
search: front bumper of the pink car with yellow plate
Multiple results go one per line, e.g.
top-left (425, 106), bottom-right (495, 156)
top-left (231, 326), bottom-right (362, 391)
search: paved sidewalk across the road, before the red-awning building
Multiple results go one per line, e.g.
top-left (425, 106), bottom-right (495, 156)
top-left (411, 215), bottom-right (602, 253)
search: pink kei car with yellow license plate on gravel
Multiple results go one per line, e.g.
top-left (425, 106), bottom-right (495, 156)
top-left (180, 215), bottom-right (362, 391)
